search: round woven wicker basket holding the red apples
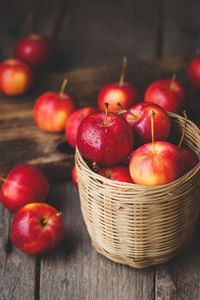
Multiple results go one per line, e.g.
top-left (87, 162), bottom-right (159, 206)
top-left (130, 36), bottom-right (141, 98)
top-left (76, 113), bottom-right (200, 268)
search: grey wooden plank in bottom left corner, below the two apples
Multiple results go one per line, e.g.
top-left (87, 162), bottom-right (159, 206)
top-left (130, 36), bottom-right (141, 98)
top-left (0, 205), bottom-right (36, 300)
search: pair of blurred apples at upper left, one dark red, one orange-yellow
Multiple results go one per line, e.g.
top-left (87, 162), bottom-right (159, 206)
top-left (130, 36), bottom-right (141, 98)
top-left (0, 34), bottom-right (55, 96)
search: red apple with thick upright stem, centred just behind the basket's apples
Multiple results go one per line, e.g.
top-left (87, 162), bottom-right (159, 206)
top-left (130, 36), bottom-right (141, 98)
top-left (98, 56), bottom-right (141, 112)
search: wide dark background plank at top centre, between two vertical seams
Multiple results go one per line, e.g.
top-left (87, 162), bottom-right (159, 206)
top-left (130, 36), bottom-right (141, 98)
top-left (57, 0), bottom-right (158, 68)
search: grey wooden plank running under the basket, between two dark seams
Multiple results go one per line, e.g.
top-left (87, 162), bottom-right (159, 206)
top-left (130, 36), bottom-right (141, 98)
top-left (40, 182), bottom-right (154, 300)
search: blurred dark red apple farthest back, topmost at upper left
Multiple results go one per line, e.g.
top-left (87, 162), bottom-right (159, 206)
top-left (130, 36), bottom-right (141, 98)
top-left (13, 34), bottom-right (55, 69)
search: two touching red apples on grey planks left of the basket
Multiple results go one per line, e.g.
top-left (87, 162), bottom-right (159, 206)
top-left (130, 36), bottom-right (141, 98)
top-left (0, 164), bottom-right (64, 254)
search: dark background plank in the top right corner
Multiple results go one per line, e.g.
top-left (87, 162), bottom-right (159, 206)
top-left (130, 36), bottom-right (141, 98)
top-left (163, 0), bottom-right (200, 55)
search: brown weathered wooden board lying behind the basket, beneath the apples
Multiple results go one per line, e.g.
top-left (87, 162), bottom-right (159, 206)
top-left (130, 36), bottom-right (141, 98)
top-left (0, 51), bottom-right (200, 180)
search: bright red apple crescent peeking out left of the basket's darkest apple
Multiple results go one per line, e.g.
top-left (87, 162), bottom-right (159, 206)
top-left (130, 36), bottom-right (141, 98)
top-left (65, 107), bottom-right (98, 148)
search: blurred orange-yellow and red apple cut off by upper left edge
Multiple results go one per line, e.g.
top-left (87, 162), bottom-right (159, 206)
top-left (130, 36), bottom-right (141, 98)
top-left (0, 58), bottom-right (33, 96)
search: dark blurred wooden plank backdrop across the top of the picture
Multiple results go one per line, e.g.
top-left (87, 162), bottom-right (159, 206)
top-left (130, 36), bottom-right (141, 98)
top-left (0, 0), bottom-right (200, 70)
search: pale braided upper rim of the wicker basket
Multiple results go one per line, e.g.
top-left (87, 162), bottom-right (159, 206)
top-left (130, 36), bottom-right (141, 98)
top-left (75, 111), bottom-right (200, 192)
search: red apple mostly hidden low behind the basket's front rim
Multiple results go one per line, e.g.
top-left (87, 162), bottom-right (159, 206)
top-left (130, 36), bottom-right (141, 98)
top-left (97, 165), bottom-right (133, 183)
